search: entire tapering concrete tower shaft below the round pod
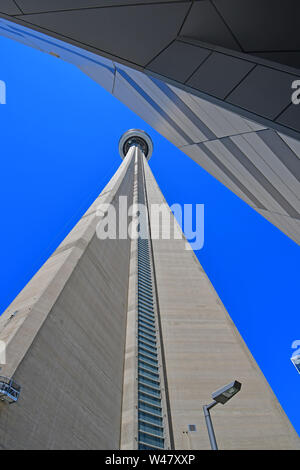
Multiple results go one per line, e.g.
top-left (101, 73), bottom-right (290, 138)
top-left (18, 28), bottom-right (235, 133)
top-left (0, 130), bottom-right (300, 450)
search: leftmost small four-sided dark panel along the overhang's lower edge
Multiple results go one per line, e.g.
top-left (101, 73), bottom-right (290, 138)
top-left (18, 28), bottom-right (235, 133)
top-left (147, 41), bottom-right (211, 83)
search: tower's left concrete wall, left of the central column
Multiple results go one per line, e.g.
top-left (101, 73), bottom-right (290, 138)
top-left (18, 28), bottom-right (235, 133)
top-left (0, 149), bottom-right (133, 449)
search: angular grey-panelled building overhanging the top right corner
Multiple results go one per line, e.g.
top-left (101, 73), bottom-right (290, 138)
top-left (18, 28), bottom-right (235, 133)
top-left (0, 5), bottom-right (300, 244)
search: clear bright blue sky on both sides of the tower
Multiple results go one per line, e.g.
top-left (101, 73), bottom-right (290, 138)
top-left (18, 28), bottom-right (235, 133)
top-left (0, 37), bottom-right (300, 434)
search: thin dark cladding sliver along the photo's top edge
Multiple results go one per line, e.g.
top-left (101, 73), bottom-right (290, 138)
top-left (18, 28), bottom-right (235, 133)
top-left (16, 0), bottom-right (184, 14)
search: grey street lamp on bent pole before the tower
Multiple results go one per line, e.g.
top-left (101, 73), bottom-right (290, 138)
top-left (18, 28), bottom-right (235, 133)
top-left (203, 380), bottom-right (242, 450)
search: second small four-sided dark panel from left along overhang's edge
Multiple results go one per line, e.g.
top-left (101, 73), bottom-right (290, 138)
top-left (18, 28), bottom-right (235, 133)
top-left (186, 52), bottom-right (255, 99)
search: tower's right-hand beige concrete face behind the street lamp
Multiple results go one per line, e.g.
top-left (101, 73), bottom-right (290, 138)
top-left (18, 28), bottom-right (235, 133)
top-left (145, 159), bottom-right (300, 449)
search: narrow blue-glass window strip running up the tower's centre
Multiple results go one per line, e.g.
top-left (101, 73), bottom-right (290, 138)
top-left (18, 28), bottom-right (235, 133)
top-left (137, 152), bottom-right (165, 450)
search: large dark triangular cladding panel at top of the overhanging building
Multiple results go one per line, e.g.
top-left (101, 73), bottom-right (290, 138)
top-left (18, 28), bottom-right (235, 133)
top-left (18, 2), bottom-right (190, 66)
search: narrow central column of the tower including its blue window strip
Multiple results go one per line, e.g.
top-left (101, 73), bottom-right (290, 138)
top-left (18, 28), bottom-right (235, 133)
top-left (121, 141), bottom-right (171, 450)
